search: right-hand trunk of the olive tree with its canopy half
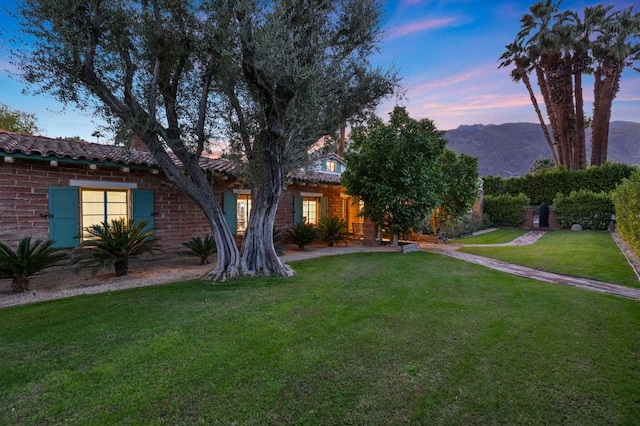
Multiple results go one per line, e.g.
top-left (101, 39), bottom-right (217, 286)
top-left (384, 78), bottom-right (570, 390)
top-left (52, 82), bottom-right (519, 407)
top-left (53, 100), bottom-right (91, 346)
top-left (212, 0), bottom-right (397, 275)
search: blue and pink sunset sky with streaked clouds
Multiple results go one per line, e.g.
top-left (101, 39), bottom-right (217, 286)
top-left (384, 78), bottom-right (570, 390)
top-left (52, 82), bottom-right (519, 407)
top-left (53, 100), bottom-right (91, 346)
top-left (0, 0), bottom-right (640, 141)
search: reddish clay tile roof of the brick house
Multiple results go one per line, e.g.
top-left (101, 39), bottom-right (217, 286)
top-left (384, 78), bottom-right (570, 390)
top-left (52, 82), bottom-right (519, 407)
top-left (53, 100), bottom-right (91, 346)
top-left (0, 130), bottom-right (340, 185)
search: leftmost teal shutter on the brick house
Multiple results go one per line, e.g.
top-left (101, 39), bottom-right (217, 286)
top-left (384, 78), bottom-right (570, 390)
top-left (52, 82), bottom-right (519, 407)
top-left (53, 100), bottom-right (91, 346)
top-left (49, 186), bottom-right (80, 248)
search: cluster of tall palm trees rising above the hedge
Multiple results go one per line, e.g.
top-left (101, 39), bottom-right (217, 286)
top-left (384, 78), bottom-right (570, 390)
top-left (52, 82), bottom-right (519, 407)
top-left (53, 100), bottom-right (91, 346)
top-left (500, 0), bottom-right (640, 169)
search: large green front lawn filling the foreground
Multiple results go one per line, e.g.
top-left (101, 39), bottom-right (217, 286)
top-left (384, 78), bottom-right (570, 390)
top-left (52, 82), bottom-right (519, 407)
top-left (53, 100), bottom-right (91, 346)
top-left (0, 253), bottom-right (640, 425)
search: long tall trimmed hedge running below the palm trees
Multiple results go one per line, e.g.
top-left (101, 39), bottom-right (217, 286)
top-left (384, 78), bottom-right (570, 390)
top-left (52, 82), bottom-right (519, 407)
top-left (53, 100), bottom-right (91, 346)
top-left (484, 163), bottom-right (637, 205)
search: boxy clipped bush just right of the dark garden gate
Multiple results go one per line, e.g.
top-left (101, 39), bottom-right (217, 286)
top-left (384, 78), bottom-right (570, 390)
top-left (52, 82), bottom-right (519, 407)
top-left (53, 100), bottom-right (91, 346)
top-left (553, 190), bottom-right (615, 230)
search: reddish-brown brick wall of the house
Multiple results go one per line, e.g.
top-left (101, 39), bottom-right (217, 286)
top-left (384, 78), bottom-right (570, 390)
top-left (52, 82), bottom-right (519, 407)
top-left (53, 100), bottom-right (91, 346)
top-left (0, 159), bottom-right (343, 254)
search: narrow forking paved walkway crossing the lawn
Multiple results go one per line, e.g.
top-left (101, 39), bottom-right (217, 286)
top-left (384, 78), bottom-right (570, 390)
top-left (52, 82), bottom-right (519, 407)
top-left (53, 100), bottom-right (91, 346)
top-left (421, 231), bottom-right (640, 300)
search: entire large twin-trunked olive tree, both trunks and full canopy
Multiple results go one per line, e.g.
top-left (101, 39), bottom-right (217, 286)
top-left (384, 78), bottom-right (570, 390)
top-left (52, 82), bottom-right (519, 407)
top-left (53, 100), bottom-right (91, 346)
top-left (14, 0), bottom-right (396, 280)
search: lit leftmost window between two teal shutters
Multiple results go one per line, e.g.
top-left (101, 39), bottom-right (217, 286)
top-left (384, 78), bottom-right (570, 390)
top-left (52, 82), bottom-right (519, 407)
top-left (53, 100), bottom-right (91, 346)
top-left (80, 189), bottom-right (129, 236)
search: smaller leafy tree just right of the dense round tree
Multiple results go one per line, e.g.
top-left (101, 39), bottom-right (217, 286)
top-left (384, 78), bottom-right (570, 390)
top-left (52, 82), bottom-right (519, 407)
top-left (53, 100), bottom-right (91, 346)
top-left (434, 149), bottom-right (478, 233)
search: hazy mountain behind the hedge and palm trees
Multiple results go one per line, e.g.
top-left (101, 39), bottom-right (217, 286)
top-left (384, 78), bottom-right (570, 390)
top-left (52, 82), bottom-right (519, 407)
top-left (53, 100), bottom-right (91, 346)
top-left (444, 121), bottom-right (640, 177)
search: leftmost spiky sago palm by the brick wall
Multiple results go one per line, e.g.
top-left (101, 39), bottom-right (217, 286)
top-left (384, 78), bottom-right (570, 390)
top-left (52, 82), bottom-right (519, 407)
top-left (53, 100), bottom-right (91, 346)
top-left (0, 237), bottom-right (69, 293)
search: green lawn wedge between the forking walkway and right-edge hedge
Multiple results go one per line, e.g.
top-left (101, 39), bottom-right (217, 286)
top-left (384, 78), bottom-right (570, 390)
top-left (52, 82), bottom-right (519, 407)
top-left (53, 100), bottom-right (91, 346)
top-left (460, 231), bottom-right (640, 287)
